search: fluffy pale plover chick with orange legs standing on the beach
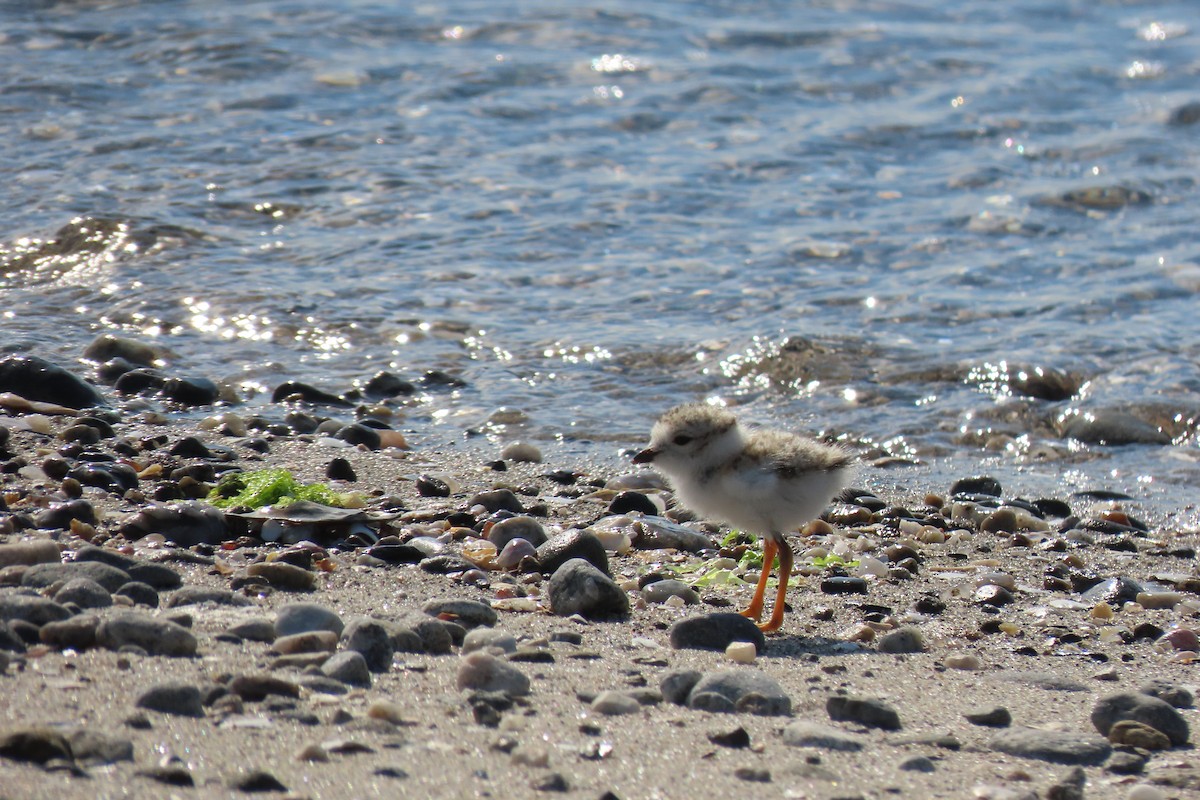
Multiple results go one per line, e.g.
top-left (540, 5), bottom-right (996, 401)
top-left (634, 403), bottom-right (851, 632)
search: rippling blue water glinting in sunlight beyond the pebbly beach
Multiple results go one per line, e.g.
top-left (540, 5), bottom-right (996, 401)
top-left (0, 0), bottom-right (1200, 524)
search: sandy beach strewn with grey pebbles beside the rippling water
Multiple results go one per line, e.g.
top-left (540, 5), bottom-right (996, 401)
top-left (0, 352), bottom-right (1200, 800)
